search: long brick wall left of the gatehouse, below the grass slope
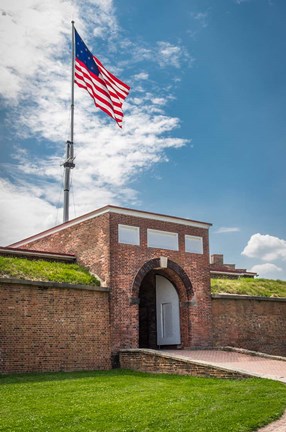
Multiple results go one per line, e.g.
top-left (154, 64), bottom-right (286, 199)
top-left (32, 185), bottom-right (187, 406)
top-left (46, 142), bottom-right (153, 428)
top-left (0, 279), bottom-right (111, 373)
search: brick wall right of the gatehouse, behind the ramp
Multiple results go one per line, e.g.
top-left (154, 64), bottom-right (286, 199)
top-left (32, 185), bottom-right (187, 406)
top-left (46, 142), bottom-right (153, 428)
top-left (212, 295), bottom-right (286, 356)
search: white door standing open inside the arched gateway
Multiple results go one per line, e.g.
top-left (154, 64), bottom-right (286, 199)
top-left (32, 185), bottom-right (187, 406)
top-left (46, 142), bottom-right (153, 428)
top-left (156, 276), bottom-right (181, 345)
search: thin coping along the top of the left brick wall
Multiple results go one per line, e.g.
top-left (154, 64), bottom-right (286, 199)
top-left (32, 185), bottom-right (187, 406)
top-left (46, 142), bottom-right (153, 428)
top-left (0, 278), bottom-right (110, 293)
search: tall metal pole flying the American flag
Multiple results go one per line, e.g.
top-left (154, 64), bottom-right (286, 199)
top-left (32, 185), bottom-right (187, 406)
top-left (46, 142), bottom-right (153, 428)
top-left (63, 21), bottom-right (75, 222)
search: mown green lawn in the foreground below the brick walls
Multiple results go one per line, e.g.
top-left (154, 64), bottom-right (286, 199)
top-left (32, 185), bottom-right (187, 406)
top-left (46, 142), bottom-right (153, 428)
top-left (0, 370), bottom-right (286, 432)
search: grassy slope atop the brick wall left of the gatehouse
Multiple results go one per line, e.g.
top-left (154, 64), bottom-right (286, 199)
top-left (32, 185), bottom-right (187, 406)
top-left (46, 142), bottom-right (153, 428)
top-left (0, 256), bottom-right (100, 285)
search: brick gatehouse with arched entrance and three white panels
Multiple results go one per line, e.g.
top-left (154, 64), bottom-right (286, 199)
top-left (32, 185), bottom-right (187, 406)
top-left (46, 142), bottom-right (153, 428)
top-left (11, 206), bottom-right (212, 362)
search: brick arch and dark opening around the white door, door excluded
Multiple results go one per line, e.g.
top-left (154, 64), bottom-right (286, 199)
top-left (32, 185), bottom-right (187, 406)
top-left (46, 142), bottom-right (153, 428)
top-left (133, 258), bottom-right (193, 349)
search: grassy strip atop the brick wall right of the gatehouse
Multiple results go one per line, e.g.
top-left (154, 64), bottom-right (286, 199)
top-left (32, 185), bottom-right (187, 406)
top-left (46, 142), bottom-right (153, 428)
top-left (211, 278), bottom-right (286, 297)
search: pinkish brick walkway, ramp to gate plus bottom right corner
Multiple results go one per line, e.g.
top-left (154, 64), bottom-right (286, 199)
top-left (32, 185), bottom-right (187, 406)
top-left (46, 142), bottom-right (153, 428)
top-left (164, 350), bottom-right (286, 432)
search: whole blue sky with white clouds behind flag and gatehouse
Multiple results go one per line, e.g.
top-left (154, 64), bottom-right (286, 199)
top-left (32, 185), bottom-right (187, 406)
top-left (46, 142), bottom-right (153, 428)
top-left (0, 0), bottom-right (286, 279)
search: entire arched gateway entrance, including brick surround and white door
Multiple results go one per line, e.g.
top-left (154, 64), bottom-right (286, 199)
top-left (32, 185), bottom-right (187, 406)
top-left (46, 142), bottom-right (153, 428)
top-left (133, 258), bottom-right (193, 349)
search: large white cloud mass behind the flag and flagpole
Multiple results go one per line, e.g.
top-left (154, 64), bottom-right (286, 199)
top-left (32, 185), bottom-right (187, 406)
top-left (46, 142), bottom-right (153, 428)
top-left (0, 0), bottom-right (192, 244)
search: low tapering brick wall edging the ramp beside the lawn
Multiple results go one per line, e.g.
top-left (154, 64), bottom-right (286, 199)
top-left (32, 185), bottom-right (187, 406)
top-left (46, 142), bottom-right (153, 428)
top-left (119, 349), bottom-right (250, 378)
